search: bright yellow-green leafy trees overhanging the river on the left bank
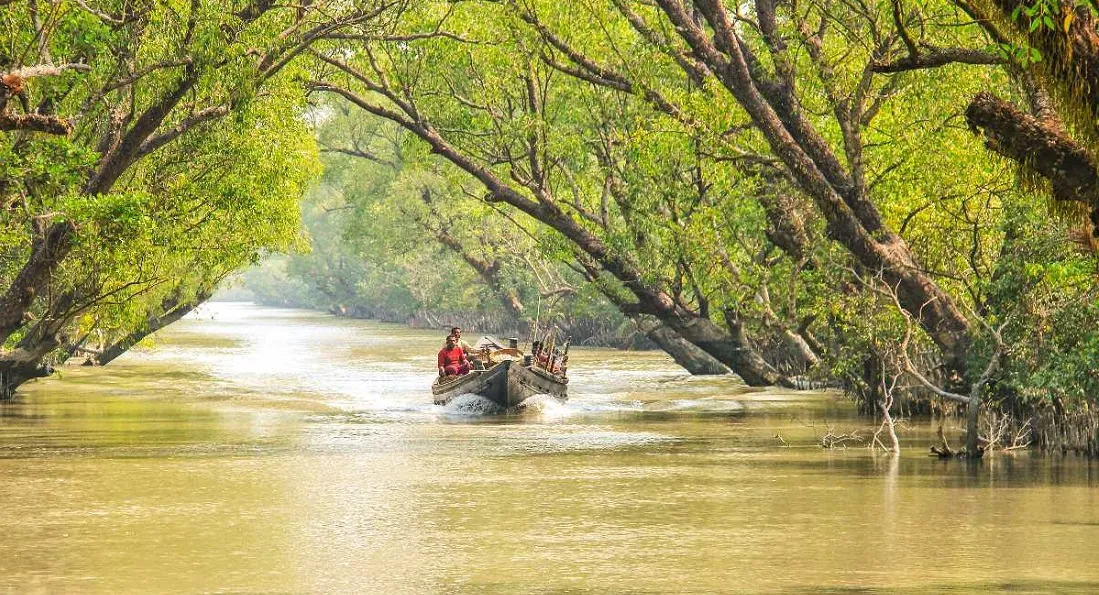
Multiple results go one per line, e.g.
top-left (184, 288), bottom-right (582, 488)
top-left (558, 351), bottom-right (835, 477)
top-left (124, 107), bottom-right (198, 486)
top-left (0, 1), bottom-right (384, 393)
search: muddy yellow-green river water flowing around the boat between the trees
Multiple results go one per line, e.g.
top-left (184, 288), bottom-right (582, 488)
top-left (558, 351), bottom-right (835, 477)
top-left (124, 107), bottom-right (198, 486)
top-left (0, 304), bottom-right (1099, 594)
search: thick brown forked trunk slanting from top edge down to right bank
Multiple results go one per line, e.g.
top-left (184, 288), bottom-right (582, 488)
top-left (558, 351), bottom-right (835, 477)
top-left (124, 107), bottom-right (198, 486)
top-left (657, 0), bottom-right (970, 375)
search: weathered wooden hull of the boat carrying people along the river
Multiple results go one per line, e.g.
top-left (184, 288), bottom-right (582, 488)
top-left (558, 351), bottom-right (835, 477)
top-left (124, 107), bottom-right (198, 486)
top-left (431, 360), bottom-right (568, 408)
